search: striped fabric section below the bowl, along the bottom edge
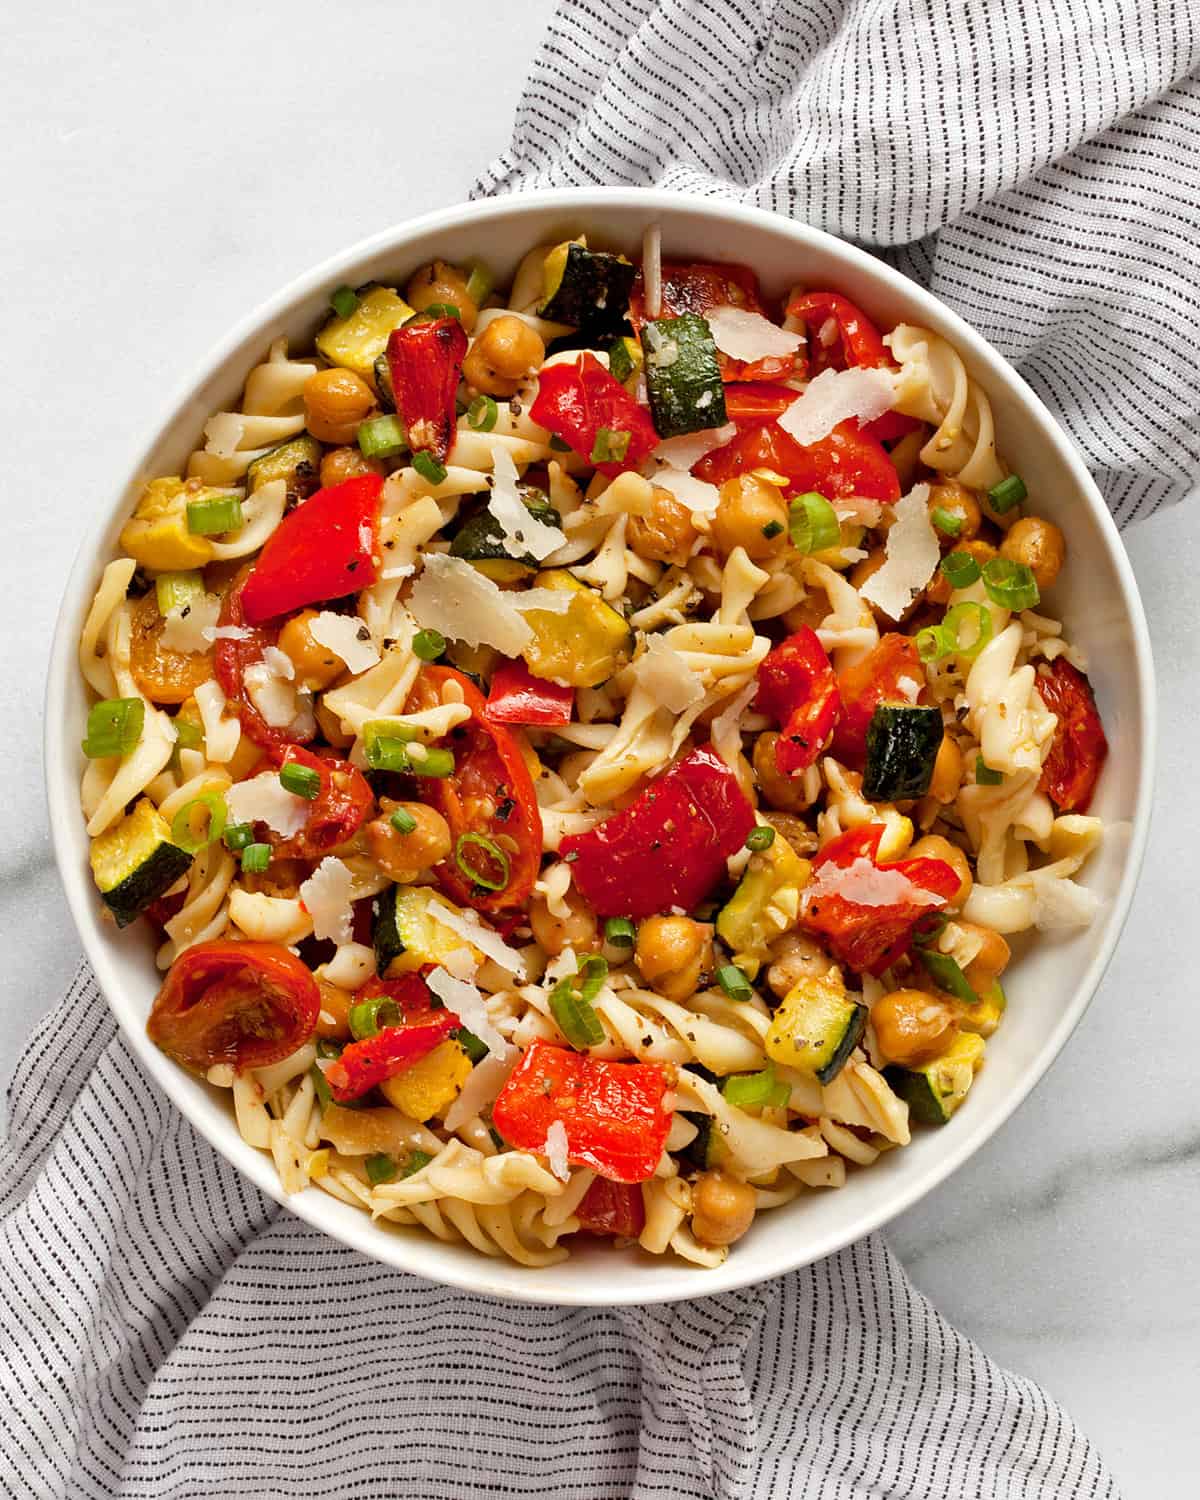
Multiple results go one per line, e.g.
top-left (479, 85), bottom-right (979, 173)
top-left (0, 969), bottom-right (1116, 1500)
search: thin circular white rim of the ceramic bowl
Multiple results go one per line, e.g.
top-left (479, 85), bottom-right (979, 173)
top-left (42, 188), bottom-right (1158, 1307)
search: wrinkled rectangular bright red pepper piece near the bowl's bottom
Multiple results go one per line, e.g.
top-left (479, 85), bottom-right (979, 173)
top-left (492, 1041), bottom-right (674, 1182)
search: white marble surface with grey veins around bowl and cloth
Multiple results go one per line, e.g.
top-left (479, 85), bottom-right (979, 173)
top-left (0, 0), bottom-right (1200, 1500)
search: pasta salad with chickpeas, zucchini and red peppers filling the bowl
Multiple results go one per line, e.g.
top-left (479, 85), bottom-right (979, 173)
top-left (80, 228), bottom-right (1107, 1266)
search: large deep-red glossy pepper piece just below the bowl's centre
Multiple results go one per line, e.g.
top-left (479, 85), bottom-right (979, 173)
top-left (560, 746), bottom-right (755, 917)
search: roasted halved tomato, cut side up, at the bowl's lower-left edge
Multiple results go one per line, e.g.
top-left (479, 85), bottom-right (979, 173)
top-left (146, 941), bottom-right (321, 1073)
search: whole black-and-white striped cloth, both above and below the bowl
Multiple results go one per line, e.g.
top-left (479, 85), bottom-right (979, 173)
top-left (14, 0), bottom-right (1200, 1500)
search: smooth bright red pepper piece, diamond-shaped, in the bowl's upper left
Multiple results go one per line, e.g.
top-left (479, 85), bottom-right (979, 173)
top-left (242, 474), bottom-right (384, 626)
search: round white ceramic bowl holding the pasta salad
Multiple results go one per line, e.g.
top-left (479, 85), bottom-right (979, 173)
top-left (45, 189), bottom-right (1155, 1307)
